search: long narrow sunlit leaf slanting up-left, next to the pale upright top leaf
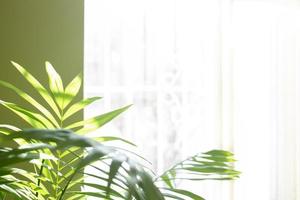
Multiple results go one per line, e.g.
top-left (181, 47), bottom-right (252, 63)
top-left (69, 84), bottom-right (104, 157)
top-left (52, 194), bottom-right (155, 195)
top-left (11, 61), bottom-right (61, 118)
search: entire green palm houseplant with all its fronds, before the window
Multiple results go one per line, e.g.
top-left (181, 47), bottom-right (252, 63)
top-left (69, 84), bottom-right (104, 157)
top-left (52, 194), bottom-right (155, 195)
top-left (0, 62), bottom-right (239, 200)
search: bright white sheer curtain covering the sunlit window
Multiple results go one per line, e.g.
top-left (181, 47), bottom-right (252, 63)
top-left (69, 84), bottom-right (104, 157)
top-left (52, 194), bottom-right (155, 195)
top-left (85, 0), bottom-right (300, 200)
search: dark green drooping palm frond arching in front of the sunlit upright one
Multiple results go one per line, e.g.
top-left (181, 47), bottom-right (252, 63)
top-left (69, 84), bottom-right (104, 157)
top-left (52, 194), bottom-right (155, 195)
top-left (0, 129), bottom-right (164, 200)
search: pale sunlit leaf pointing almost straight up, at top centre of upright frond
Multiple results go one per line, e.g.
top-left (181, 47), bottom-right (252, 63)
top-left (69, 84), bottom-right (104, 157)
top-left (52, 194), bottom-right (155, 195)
top-left (45, 61), bottom-right (64, 110)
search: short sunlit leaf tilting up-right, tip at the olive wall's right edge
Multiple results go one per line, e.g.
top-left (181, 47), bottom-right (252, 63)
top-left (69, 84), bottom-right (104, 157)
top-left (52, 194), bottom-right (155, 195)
top-left (62, 73), bottom-right (82, 109)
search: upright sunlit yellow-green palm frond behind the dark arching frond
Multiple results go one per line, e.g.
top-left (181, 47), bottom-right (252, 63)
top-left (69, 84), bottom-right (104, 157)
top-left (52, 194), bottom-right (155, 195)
top-left (0, 62), bottom-right (129, 200)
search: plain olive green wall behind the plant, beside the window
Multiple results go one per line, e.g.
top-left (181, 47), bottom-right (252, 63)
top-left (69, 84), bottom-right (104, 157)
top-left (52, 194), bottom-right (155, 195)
top-left (0, 0), bottom-right (84, 127)
